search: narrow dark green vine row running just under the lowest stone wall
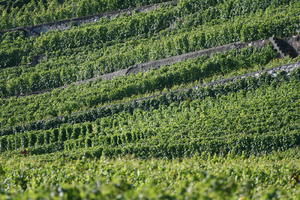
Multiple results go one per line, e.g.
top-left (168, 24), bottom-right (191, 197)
top-left (1, 65), bottom-right (300, 135)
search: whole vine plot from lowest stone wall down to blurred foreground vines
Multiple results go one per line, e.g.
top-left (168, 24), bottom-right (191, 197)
top-left (0, 73), bottom-right (300, 158)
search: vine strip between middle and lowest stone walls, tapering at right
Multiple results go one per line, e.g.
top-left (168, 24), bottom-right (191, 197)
top-left (1, 46), bottom-right (277, 127)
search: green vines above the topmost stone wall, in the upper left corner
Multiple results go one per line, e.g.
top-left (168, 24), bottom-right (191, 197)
top-left (0, 0), bottom-right (172, 30)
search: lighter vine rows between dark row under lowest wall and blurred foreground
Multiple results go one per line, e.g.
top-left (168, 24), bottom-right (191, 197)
top-left (0, 77), bottom-right (300, 157)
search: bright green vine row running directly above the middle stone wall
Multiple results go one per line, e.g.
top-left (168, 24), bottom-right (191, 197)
top-left (0, 0), bottom-right (299, 96)
